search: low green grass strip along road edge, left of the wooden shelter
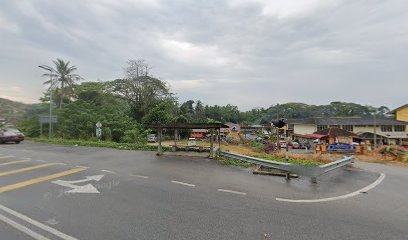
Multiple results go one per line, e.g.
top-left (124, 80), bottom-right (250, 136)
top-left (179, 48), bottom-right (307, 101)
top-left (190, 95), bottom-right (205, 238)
top-left (32, 138), bottom-right (170, 151)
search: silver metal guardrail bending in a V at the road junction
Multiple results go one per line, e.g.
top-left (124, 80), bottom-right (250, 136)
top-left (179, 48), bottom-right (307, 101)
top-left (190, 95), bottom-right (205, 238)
top-left (220, 151), bottom-right (354, 183)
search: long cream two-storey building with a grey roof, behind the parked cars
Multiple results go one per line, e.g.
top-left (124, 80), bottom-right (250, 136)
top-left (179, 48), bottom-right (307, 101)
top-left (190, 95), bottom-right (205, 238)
top-left (287, 117), bottom-right (408, 144)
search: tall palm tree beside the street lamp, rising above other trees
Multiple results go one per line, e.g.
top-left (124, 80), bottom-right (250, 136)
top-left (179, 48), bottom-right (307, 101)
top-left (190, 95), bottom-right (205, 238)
top-left (43, 58), bottom-right (81, 108)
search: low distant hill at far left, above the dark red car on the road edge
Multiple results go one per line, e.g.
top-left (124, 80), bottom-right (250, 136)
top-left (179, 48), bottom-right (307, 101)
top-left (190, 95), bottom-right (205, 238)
top-left (0, 98), bottom-right (31, 124)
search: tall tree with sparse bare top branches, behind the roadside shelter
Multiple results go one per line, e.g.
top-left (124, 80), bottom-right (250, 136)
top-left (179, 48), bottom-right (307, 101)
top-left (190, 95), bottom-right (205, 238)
top-left (110, 60), bottom-right (175, 121)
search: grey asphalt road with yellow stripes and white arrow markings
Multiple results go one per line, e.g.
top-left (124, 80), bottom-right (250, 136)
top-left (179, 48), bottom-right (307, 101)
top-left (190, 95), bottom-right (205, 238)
top-left (0, 141), bottom-right (408, 240)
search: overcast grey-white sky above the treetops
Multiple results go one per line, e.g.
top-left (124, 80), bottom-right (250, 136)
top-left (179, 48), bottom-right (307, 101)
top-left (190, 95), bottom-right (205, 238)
top-left (0, 0), bottom-right (408, 110)
